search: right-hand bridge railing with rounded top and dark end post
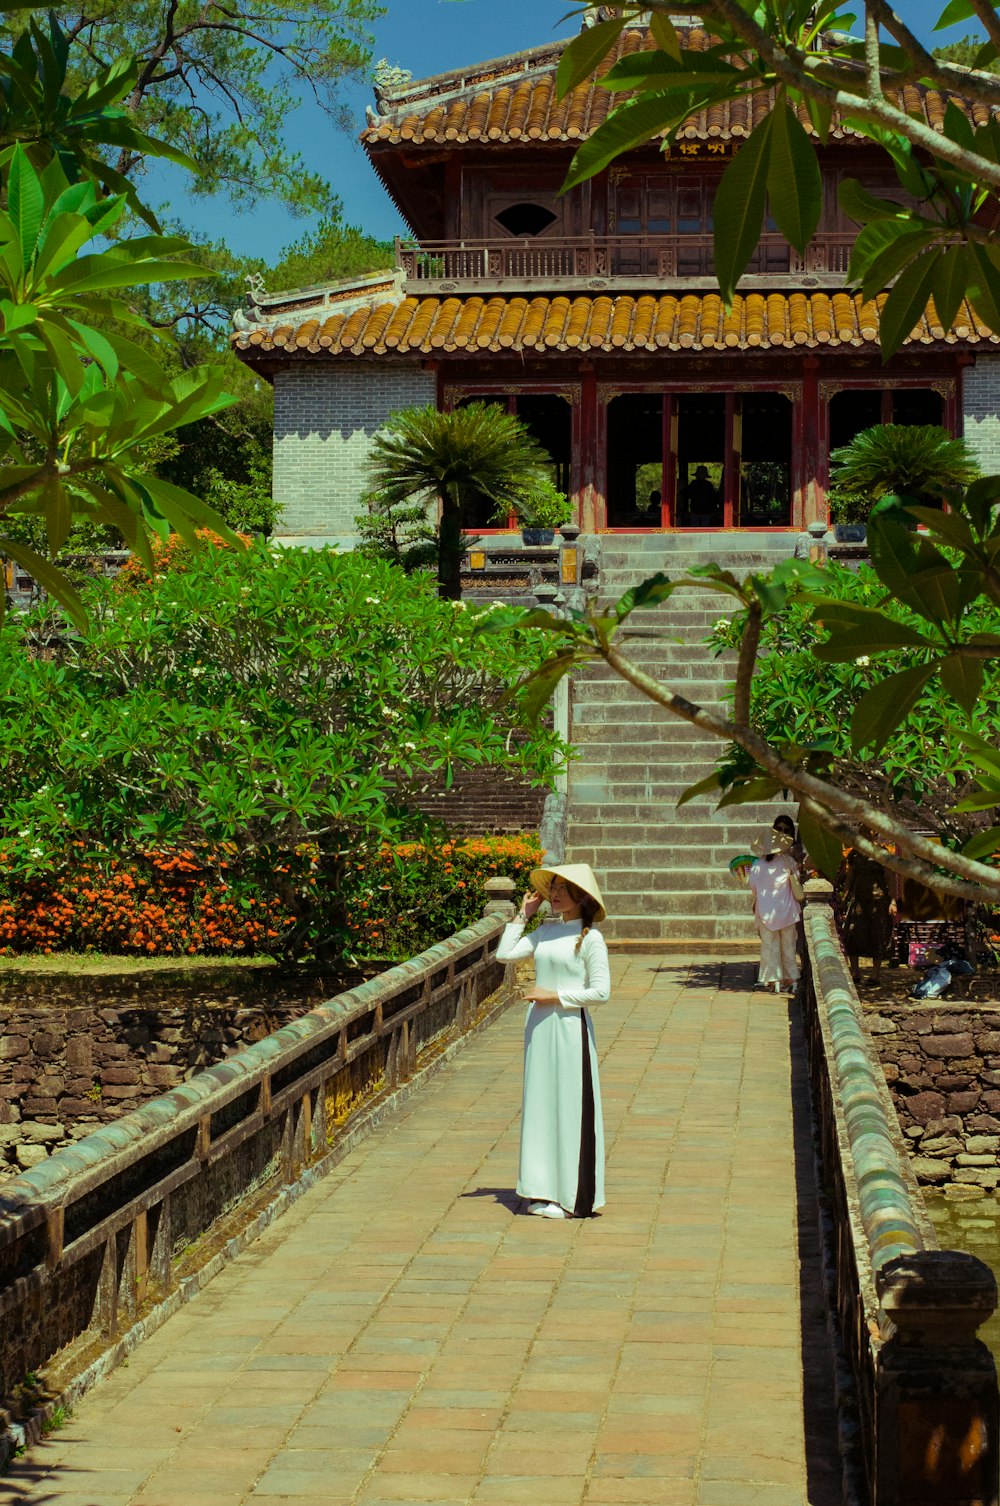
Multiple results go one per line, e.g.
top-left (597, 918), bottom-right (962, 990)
top-left (804, 880), bottom-right (1000, 1506)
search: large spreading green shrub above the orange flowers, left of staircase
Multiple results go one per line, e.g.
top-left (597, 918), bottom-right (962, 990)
top-left (0, 544), bottom-right (560, 962)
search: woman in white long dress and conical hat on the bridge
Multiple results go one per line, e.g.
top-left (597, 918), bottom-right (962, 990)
top-left (497, 863), bottom-right (611, 1218)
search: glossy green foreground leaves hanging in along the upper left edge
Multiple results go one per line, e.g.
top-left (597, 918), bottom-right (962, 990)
top-left (0, 8), bottom-right (240, 625)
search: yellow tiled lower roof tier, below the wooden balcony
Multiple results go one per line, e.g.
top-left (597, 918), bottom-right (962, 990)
top-left (233, 292), bottom-right (1000, 360)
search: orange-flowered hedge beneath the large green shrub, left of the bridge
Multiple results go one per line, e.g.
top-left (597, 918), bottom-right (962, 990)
top-left (0, 837), bottom-right (541, 959)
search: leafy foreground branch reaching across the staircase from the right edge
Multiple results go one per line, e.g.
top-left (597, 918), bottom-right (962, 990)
top-left (483, 476), bottom-right (1000, 905)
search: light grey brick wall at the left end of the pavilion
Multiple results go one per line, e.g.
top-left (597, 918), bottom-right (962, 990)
top-left (274, 361), bottom-right (437, 544)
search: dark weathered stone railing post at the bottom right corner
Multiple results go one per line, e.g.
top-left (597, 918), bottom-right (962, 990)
top-left (873, 1250), bottom-right (1000, 1506)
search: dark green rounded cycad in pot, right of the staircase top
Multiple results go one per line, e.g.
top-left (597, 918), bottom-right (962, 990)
top-left (830, 423), bottom-right (979, 538)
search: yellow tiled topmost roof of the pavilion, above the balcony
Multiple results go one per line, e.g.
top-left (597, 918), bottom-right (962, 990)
top-left (361, 27), bottom-right (989, 146)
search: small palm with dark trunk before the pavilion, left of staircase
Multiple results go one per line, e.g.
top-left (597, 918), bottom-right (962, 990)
top-left (369, 402), bottom-right (551, 601)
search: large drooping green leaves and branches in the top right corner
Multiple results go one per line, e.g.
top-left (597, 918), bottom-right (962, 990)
top-left (557, 0), bottom-right (1000, 354)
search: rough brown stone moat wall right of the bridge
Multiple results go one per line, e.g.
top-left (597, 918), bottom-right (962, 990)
top-left (866, 1000), bottom-right (1000, 1197)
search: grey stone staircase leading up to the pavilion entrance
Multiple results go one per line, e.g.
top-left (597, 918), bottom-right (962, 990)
top-left (566, 533), bottom-right (795, 952)
